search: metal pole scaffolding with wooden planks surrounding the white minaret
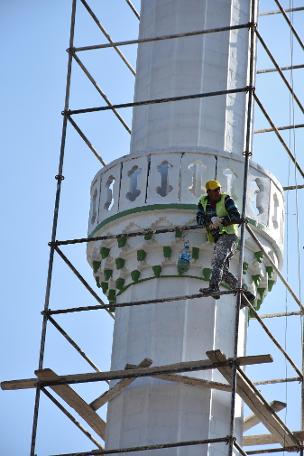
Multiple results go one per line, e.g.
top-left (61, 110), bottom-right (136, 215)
top-left (1, 0), bottom-right (304, 456)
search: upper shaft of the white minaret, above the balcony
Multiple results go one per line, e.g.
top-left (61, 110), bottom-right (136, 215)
top-left (131, 0), bottom-right (250, 157)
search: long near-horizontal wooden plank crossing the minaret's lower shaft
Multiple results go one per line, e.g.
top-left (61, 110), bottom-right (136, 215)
top-left (1, 355), bottom-right (273, 390)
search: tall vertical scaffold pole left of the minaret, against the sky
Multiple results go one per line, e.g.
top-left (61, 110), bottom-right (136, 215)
top-left (30, 0), bottom-right (77, 456)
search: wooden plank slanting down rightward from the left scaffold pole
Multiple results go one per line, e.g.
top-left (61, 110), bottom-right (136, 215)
top-left (37, 369), bottom-right (106, 440)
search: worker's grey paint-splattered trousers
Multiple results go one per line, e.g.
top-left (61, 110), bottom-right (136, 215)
top-left (210, 234), bottom-right (238, 288)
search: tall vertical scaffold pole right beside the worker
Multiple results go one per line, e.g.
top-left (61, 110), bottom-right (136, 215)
top-left (228, 0), bottom-right (257, 456)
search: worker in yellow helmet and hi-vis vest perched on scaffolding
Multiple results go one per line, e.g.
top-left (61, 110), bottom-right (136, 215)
top-left (196, 180), bottom-right (255, 307)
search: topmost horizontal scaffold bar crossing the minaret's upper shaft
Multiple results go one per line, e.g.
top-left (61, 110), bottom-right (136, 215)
top-left (71, 22), bottom-right (255, 52)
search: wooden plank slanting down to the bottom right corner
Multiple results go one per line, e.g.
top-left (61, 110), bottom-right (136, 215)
top-left (207, 350), bottom-right (299, 447)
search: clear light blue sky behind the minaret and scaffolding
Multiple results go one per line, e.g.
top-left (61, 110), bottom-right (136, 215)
top-left (0, 0), bottom-right (304, 456)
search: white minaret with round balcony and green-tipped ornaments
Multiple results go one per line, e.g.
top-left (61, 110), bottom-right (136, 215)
top-left (88, 0), bottom-right (284, 456)
